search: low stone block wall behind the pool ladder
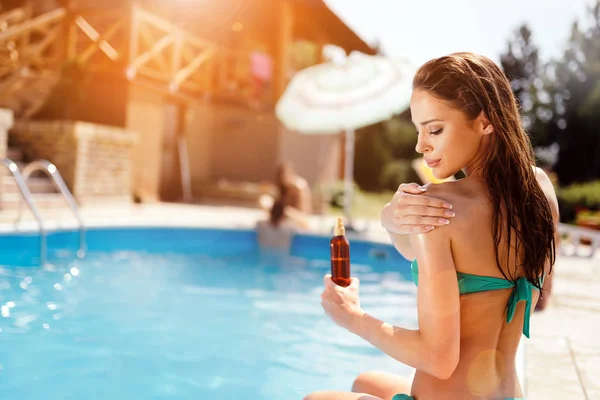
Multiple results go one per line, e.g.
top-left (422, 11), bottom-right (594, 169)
top-left (10, 121), bottom-right (137, 204)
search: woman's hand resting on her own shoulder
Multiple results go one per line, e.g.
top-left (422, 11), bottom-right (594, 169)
top-left (381, 183), bottom-right (454, 235)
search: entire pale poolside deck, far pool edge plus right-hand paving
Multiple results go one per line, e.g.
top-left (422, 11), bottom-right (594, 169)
top-left (0, 204), bottom-right (600, 400)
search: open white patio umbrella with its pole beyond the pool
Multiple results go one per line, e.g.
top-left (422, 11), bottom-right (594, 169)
top-left (275, 45), bottom-right (414, 226)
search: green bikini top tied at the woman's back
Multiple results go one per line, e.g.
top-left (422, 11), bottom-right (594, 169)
top-left (410, 260), bottom-right (544, 338)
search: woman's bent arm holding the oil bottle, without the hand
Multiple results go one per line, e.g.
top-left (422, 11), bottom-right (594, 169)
top-left (349, 228), bottom-right (460, 379)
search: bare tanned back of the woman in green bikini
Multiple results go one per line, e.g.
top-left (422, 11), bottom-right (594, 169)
top-left (413, 178), bottom-right (552, 400)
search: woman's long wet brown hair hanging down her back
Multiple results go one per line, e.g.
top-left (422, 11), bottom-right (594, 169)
top-left (413, 53), bottom-right (556, 291)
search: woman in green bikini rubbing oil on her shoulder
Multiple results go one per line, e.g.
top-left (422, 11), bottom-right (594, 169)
top-left (306, 53), bottom-right (558, 400)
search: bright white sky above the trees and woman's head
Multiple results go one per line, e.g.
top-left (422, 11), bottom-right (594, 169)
top-left (325, 0), bottom-right (593, 65)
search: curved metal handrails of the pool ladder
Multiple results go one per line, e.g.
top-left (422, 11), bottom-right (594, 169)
top-left (1, 158), bottom-right (86, 265)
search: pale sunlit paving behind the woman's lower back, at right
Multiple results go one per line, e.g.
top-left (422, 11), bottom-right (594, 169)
top-left (525, 254), bottom-right (600, 400)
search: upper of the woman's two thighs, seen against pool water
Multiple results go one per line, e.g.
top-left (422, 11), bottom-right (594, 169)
top-left (352, 371), bottom-right (412, 400)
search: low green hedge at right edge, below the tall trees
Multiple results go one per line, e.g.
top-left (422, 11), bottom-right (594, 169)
top-left (556, 181), bottom-right (600, 222)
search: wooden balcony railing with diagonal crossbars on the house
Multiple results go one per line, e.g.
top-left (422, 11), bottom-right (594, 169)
top-left (0, 4), bottom-right (273, 116)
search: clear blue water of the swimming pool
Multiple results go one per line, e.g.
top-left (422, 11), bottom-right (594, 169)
top-left (0, 228), bottom-right (416, 400)
